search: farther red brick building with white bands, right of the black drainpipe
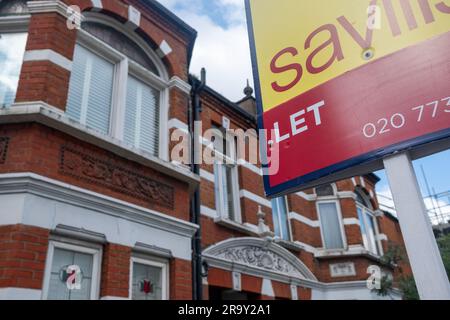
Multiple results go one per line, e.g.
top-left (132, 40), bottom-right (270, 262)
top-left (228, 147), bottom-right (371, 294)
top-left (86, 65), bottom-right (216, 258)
top-left (195, 87), bottom-right (411, 300)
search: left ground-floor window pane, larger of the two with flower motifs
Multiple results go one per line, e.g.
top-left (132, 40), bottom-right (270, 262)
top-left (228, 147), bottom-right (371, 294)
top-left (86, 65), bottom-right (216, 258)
top-left (47, 248), bottom-right (94, 300)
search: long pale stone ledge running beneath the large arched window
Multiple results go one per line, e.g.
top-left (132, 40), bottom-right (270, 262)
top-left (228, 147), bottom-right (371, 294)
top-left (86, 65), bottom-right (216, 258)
top-left (0, 101), bottom-right (200, 192)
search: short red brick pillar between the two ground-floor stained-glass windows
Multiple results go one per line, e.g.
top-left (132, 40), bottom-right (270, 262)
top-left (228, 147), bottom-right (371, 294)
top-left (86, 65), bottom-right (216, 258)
top-left (100, 244), bottom-right (131, 298)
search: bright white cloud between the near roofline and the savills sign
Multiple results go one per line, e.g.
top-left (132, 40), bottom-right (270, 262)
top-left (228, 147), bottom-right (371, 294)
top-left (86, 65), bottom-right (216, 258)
top-left (159, 0), bottom-right (253, 101)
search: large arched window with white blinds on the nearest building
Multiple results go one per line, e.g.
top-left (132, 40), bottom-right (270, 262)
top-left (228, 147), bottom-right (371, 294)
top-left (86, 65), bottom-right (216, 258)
top-left (66, 13), bottom-right (168, 157)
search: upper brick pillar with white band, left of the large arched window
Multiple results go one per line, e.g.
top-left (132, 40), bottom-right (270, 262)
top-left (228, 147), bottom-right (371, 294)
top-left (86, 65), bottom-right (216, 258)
top-left (16, 13), bottom-right (77, 111)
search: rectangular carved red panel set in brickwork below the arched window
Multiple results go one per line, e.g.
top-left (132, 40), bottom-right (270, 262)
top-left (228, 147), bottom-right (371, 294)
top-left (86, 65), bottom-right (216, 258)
top-left (60, 145), bottom-right (174, 209)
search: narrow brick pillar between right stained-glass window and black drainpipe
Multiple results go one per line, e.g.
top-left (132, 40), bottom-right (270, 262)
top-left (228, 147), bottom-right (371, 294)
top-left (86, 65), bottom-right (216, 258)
top-left (170, 259), bottom-right (192, 300)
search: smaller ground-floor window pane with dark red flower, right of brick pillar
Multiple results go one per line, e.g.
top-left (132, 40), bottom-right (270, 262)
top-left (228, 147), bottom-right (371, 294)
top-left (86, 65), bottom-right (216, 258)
top-left (132, 263), bottom-right (163, 300)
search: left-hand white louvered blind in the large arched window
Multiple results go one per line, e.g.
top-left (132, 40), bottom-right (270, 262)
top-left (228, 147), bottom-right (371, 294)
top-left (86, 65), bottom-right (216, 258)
top-left (66, 45), bottom-right (114, 134)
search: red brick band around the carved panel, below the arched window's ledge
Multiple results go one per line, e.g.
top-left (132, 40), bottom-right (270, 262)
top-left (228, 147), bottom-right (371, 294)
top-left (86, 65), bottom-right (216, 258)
top-left (0, 124), bottom-right (190, 220)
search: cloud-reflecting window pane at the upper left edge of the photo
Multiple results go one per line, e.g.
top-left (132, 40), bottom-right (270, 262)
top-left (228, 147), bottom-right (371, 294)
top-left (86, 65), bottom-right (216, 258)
top-left (0, 33), bottom-right (27, 108)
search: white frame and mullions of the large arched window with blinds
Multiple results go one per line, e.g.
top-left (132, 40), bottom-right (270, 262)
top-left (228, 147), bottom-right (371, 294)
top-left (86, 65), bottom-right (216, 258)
top-left (67, 13), bottom-right (170, 161)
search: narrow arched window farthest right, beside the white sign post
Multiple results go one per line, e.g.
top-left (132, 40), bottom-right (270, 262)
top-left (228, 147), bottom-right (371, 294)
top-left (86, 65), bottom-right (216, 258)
top-left (355, 188), bottom-right (380, 255)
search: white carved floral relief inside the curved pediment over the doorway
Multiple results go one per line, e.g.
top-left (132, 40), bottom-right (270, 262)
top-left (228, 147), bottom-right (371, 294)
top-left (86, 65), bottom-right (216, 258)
top-left (217, 246), bottom-right (300, 276)
